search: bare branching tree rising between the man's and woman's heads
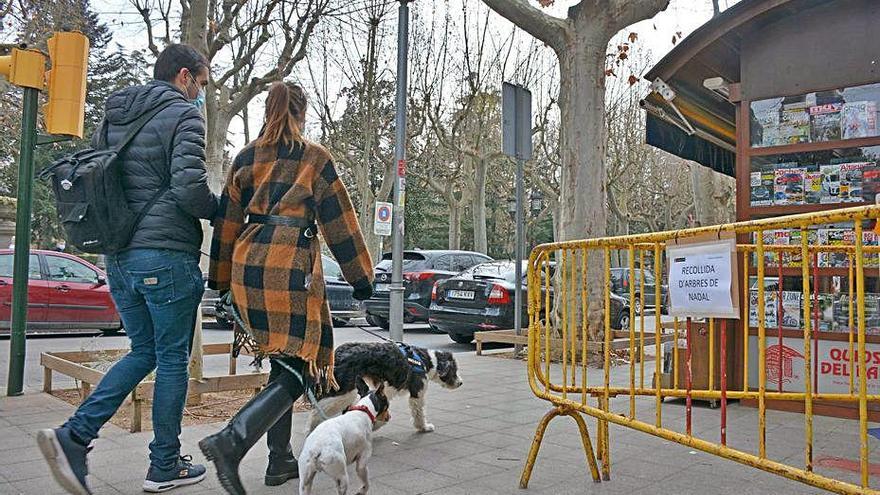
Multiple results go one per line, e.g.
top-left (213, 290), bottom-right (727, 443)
top-left (131, 0), bottom-right (335, 190)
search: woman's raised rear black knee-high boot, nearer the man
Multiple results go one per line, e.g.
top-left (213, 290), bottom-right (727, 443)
top-left (199, 361), bottom-right (302, 495)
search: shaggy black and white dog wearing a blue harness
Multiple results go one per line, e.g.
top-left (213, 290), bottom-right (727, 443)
top-left (309, 342), bottom-right (462, 433)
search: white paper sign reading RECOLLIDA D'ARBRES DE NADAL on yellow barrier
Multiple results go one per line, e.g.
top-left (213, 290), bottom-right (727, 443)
top-left (666, 239), bottom-right (739, 318)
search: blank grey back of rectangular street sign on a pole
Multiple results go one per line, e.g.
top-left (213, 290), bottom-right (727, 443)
top-left (501, 83), bottom-right (532, 160)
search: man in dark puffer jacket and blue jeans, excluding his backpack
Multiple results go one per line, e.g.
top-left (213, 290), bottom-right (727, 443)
top-left (37, 45), bottom-right (217, 494)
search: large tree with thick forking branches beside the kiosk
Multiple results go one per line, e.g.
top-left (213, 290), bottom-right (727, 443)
top-left (483, 0), bottom-right (669, 340)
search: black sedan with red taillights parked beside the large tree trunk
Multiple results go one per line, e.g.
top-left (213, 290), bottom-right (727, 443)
top-left (428, 261), bottom-right (629, 344)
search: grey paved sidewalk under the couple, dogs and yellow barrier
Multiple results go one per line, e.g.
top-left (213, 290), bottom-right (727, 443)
top-left (0, 353), bottom-right (852, 495)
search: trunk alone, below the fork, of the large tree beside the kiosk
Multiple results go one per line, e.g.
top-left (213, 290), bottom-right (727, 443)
top-left (557, 25), bottom-right (609, 340)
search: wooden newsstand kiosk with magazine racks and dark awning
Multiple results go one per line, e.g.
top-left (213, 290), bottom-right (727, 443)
top-left (642, 0), bottom-right (880, 421)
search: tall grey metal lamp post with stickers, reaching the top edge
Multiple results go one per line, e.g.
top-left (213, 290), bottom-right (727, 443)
top-left (389, 0), bottom-right (411, 342)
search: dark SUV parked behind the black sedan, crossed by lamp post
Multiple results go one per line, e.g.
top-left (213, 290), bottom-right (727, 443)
top-left (364, 250), bottom-right (492, 329)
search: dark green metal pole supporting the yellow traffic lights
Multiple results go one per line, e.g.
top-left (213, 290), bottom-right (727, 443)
top-left (6, 88), bottom-right (40, 397)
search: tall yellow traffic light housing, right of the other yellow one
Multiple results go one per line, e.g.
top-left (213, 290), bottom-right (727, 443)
top-left (43, 32), bottom-right (89, 138)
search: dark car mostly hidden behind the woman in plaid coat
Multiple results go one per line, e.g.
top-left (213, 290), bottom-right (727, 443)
top-left (202, 255), bottom-right (364, 328)
